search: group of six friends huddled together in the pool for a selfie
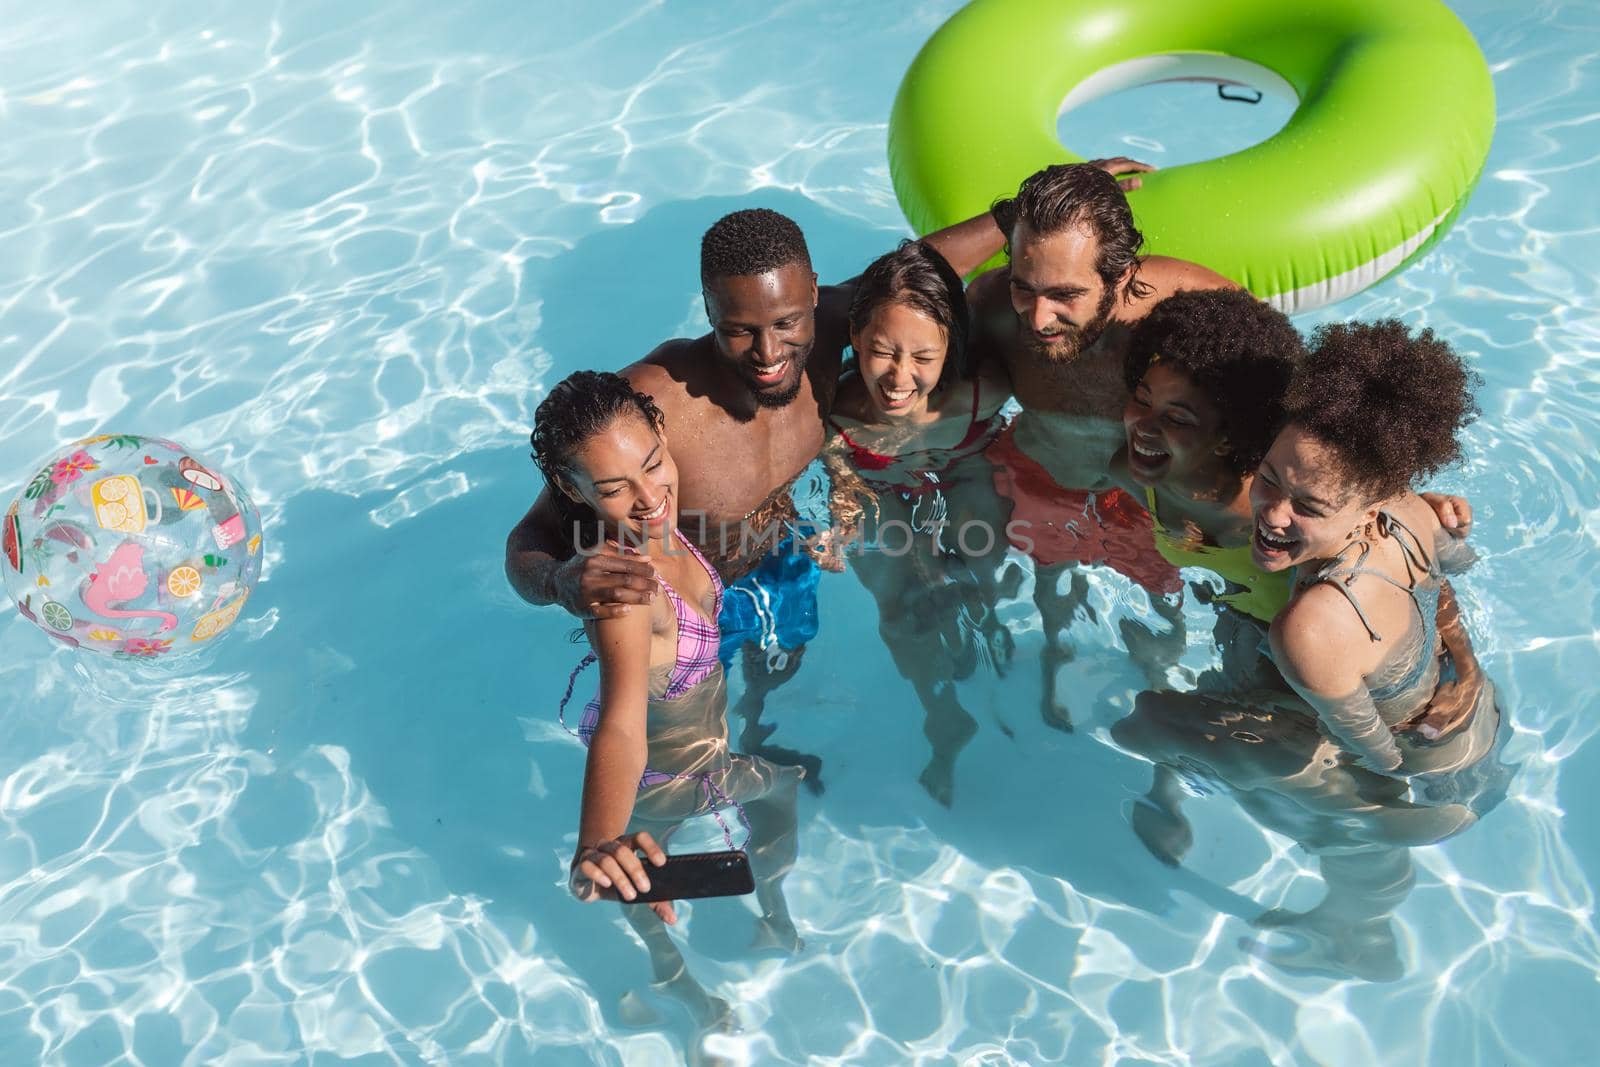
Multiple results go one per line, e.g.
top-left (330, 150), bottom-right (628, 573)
top-left (506, 160), bottom-right (1504, 1011)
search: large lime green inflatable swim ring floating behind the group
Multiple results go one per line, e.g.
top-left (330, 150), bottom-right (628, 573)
top-left (890, 0), bottom-right (1494, 312)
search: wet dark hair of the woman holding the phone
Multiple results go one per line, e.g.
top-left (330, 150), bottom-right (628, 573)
top-left (528, 371), bottom-right (667, 549)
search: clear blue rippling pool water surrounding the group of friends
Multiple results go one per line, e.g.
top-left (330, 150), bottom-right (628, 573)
top-left (0, 0), bottom-right (1600, 1067)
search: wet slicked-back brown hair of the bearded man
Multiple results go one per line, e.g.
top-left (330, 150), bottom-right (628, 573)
top-left (990, 163), bottom-right (1150, 298)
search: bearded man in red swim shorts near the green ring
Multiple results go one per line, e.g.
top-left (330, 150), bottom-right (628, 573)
top-left (966, 163), bottom-right (1235, 729)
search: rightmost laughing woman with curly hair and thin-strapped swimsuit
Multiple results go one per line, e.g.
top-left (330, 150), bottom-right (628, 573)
top-left (1250, 320), bottom-right (1499, 774)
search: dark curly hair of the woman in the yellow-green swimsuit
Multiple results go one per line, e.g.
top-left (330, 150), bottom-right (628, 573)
top-left (1123, 290), bottom-right (1306, 475)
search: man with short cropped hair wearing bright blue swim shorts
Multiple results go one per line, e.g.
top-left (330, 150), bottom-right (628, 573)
top-left (506, 208), bottom-right (1003, 784)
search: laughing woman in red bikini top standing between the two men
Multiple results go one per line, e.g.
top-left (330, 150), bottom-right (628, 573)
top-left (819, 242), bottom-right (1014, 805)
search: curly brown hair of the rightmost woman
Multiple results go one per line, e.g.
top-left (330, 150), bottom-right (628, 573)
top-left (1283, 318), bottom-right (1482, 501)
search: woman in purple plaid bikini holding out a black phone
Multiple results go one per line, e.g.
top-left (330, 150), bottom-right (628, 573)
top-left (533, 371), bottom-right (805, 1024)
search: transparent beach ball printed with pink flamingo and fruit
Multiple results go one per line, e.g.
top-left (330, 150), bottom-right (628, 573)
top-left (0, 434), bottom-right (261, 659)
